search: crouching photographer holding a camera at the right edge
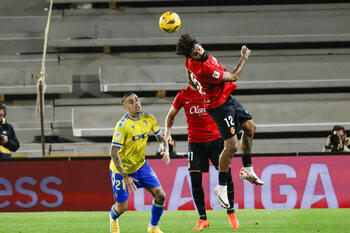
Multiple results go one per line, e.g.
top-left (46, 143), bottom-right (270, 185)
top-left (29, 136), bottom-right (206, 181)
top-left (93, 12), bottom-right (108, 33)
top-left (323, 125), bottom-right (350, 152)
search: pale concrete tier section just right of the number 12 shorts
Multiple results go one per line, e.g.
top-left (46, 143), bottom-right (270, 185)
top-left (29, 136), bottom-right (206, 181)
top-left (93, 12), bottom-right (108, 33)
top-left (237, 93), bottom-right (350, 132)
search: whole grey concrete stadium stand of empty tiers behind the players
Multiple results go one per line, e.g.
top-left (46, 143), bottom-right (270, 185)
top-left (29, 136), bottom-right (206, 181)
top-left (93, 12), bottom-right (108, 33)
top-left (0, 0), bottom-right (350, 156)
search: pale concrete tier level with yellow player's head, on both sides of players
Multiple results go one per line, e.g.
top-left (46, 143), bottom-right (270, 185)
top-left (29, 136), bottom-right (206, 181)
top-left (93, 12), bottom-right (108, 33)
top-left (72, 94), bottom-right (350, 137)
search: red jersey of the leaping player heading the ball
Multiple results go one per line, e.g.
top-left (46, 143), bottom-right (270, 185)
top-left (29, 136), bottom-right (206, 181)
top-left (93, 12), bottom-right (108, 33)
top-left (185, 54), bottom-right (237, 108)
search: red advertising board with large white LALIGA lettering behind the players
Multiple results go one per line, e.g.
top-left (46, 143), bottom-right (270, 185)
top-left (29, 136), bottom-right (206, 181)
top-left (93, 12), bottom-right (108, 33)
top-left (0, 153), bottom-right (350, 212)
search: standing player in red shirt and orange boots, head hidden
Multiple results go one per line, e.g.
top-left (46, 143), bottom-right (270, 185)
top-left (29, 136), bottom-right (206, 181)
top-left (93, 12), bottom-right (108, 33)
top-left (164, 85), bottom-right (239, 230)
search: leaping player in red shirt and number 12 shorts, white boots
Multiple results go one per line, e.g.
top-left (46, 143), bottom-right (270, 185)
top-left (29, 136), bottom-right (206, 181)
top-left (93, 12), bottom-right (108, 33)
top-left (176, 34), bottom-right (264, 208)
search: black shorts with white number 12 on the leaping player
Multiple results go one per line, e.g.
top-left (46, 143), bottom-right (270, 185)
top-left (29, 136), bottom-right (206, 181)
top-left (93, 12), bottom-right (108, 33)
top-left (207, 95), bottom-right (253, 140)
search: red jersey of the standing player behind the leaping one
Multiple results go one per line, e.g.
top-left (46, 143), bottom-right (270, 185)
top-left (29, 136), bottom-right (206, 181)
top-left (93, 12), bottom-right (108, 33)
top-left (173, 86), bottom-right (221, 143)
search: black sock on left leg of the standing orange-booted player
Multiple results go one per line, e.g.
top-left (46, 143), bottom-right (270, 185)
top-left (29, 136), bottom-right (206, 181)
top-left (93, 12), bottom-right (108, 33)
top-left (190, 172), bottom-right (207, 220)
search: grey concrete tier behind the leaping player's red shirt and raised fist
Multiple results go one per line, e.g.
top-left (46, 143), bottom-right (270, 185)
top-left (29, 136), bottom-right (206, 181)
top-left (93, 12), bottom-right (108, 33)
top-left (99, 50), bottom-right (350, 92)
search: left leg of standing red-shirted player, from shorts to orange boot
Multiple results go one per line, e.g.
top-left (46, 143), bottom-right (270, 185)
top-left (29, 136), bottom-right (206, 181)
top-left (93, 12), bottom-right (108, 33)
top-left (188, 142), bottom-right (210, 230)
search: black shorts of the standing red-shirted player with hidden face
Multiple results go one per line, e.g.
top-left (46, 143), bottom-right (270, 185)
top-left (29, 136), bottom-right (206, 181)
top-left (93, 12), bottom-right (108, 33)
top-left (188, 138), bottom-right (224, 172)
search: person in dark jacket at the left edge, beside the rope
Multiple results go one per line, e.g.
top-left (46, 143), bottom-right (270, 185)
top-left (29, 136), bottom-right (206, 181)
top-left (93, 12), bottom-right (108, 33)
top-left (0, 103), bottom-right (19, 158)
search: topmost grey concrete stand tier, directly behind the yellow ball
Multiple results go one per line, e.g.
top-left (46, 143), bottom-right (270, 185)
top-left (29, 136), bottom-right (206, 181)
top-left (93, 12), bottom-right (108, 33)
top-left (49, 4), bottom-right (350, 48)
